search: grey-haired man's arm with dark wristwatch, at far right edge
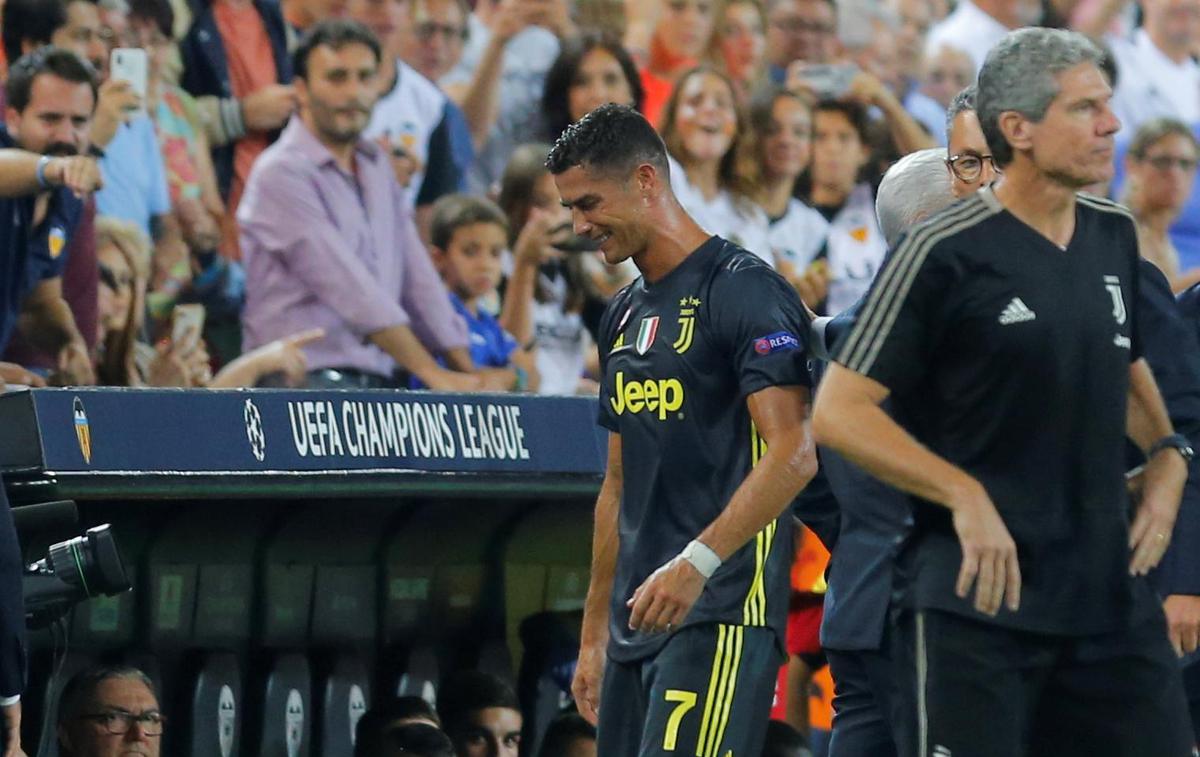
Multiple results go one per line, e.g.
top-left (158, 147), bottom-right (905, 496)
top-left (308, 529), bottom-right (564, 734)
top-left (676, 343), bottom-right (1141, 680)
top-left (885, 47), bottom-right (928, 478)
top-left (1127, 360), bottom-right (1188, 576)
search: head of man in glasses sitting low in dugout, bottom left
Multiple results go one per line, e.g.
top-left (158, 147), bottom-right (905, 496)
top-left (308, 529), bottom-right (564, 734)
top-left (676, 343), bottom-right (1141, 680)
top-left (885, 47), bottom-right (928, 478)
top-left (59, 666), bottom-right (167, 757)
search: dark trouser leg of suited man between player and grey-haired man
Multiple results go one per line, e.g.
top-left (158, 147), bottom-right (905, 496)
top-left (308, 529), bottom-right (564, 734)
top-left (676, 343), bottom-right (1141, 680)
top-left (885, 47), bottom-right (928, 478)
top-left (826, 649), bottom-right (896, 757)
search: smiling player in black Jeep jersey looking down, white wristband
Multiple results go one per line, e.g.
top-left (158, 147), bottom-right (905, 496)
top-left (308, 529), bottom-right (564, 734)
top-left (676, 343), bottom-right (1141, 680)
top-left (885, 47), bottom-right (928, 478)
top-left (546, 106), bottom-right (816, 757)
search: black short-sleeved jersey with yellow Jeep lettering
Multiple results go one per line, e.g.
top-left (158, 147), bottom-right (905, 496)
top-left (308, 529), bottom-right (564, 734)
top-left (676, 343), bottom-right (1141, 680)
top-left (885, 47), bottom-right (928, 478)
top-left (599, 236), bottom-right (810, 661)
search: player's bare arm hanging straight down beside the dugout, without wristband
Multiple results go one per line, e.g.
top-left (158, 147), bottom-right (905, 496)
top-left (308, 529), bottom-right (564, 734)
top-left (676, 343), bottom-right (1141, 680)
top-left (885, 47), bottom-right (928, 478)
top-left (571, 433), bottom-right (624, 725)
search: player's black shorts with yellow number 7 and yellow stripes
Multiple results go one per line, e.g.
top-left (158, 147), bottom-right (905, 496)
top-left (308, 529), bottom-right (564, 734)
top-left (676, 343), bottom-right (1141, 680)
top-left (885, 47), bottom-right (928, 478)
top-left (596, 624), bottom-right (782, 757)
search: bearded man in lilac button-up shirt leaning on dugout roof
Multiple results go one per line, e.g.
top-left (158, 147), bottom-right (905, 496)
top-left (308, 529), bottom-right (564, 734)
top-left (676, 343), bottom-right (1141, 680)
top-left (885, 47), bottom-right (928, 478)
top-left (238, 20), bottom-right (501, 391)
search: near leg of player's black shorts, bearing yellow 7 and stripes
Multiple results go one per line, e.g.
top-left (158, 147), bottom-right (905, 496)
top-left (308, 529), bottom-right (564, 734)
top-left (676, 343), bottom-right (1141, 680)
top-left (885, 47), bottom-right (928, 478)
top-left (638, 624), bottom-right (781, 757)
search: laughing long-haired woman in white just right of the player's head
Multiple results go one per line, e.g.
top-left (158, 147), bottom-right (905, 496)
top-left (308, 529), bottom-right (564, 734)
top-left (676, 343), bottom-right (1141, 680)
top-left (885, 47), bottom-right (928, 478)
top-left (659, 66), bottom-right (774, 264)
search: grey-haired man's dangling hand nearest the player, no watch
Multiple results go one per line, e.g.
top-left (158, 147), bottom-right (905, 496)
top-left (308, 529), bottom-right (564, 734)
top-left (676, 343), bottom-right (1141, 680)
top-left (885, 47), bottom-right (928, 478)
top-left (953, 486), bottom-right (1021, 615)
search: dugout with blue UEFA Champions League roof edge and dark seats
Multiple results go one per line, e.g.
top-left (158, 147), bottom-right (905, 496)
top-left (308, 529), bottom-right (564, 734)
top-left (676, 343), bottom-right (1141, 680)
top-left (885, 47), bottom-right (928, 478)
top-left (0, 389), bottom-right (606, 757)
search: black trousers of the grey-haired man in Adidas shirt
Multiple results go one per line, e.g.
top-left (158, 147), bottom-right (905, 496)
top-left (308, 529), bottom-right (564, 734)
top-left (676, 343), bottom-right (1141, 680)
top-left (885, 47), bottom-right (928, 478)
top-left (893, 609), bottom-right (1193, 757)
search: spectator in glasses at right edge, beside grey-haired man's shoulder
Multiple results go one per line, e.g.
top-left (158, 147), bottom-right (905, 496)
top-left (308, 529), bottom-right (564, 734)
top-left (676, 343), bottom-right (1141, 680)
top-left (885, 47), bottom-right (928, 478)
top-left (1122, 119), bottom-right (1200, 293)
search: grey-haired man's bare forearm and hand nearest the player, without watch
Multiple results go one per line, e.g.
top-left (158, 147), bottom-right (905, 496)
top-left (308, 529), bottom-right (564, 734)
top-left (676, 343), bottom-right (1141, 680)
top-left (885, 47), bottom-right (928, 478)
top-left (812, 364), bottom-right (1021, 615)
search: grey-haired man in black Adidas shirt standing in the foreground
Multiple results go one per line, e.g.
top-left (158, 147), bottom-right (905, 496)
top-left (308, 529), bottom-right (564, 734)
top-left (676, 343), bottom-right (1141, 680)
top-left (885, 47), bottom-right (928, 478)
top-left (815, 29), bottom-right (1190, 757)
